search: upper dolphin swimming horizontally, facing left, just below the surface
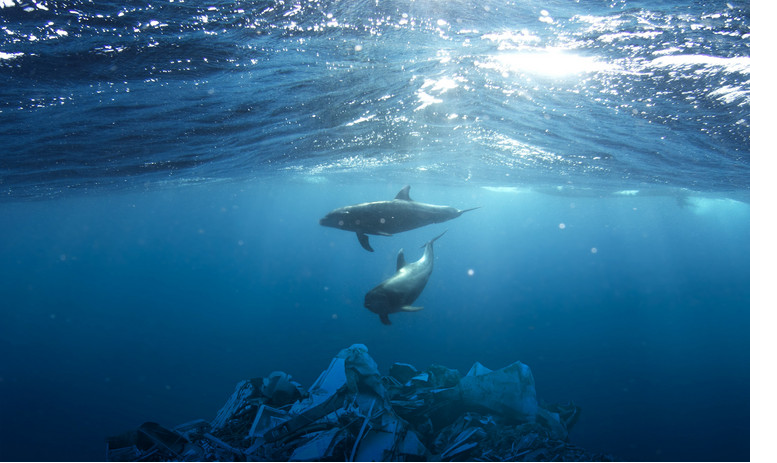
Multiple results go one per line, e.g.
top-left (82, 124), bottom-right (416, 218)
top-left (318, 185), bottom-right (477, 252)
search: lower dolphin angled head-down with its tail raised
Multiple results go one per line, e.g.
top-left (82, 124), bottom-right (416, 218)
top-left (364, 230), bottom-right (447, 325)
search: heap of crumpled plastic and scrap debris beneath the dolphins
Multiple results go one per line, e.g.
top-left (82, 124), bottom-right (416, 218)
top-left (106, 344), bottom-right (615, 461)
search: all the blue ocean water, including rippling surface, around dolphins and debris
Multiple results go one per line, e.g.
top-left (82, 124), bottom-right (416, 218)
top-left (0, 0), bottom-right (750, 461)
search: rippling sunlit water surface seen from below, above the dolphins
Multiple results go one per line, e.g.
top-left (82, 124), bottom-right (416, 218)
top-left (0, 0), bottom-right (750, 198)
